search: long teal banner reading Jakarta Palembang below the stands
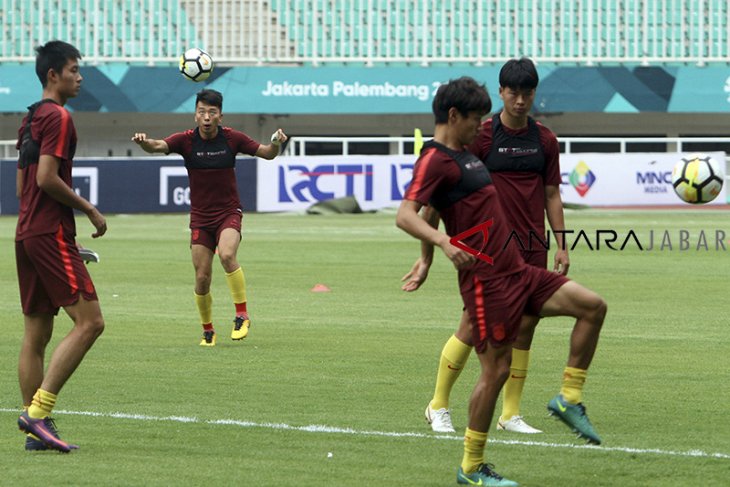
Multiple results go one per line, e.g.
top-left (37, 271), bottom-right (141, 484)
top-left (0, 62), bottom-right (730, 114)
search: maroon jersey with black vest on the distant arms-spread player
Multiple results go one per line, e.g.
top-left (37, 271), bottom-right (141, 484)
top-left (164, 127), bottom-right (260, 228)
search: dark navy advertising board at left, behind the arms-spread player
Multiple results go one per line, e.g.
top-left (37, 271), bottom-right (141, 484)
top-left (0, 157), bottom-right (257, 215)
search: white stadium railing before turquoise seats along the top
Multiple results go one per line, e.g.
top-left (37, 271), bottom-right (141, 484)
top-left (0, 0), bottom-right (730, 65)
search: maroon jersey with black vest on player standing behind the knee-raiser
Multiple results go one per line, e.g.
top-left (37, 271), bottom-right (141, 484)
top-left (469, 114), bottom-right (561, 251)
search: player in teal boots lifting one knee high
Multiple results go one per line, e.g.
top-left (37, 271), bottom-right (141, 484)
top-left (396, 77), bottom-right (606, 486)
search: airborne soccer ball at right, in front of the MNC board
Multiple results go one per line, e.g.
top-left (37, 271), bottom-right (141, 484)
top-left (672, 154), bottom-right (725, 205)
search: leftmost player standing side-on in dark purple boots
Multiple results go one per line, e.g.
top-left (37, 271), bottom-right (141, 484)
top-left (15, 41), bottom-right (106, 452)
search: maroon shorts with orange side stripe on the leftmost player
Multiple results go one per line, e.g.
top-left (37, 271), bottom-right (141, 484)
top-left (15, 228), bottom-right (99, 315)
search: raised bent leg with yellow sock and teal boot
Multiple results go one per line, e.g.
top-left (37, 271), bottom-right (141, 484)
top-left (542, 281), bottom-right (607, 444)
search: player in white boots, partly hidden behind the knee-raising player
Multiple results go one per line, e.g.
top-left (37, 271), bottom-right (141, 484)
top-left (403, 58), bottom-right (570, 433)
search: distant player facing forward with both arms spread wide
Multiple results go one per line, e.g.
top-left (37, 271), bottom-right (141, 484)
top-left (132, 90), bottom-right (287, 347)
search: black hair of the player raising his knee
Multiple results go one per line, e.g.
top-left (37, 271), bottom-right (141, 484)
top-left (431, 76), bottom-right (492, 124)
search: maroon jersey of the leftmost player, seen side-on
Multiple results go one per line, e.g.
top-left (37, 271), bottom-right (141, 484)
top-left (15, 102), bottom-right (76, 241)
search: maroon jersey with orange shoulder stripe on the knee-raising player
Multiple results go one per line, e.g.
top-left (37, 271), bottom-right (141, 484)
top-left (404, 141), bottom-right (525, 287)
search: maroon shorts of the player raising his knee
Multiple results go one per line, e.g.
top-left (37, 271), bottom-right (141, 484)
top-left (461, 265), bottom-right (568, 353)
